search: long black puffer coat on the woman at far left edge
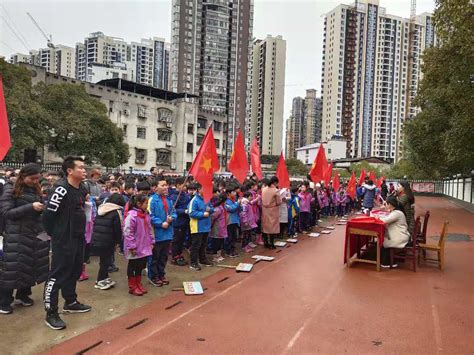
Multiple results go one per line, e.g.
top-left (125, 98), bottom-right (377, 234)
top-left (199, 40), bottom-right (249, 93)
top-left (0, 183), bottom-right (49, 289)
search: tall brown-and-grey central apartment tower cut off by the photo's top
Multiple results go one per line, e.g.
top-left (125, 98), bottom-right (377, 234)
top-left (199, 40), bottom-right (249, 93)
top-left (170, 0), bottom-right (253, 159)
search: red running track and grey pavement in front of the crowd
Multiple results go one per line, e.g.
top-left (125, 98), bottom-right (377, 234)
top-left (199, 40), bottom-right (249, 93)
top-left (0, 197), bottom-right (474, 354)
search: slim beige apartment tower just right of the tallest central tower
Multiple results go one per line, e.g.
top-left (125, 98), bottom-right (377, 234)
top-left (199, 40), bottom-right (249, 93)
top-left (245, 36), bottom-right (286, 155)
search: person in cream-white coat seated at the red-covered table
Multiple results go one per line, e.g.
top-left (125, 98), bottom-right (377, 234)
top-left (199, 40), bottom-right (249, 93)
top-left (380, 196), bottom-right (410, 268)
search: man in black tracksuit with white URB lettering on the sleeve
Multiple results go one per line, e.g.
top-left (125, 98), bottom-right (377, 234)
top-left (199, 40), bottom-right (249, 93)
top-left (43, 157), bottom-right (91, 330)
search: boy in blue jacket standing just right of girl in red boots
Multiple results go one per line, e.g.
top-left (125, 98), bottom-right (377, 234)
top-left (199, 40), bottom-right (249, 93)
top-left (148, 177), bottom-right (176, 287)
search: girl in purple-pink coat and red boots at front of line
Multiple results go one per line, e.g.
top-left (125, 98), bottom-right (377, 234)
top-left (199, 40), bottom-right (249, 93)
top-left (123, 194), bottom-right (155, 296)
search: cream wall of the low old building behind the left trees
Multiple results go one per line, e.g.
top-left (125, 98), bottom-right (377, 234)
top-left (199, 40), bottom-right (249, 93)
top-left (28, 66), bottom-right (226, 173)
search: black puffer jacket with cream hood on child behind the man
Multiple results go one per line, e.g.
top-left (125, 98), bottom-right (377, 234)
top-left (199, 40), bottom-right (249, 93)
top-left (91, 202), bottom-right (123, 252)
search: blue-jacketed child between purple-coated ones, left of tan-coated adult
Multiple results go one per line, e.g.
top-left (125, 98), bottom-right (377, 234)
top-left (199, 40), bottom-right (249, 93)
top-left (224, 185), bottom-right (240, 258)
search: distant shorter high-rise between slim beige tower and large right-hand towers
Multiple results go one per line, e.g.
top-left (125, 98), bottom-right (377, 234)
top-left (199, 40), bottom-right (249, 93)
top-left (286, 89), bottom-right (322, 158)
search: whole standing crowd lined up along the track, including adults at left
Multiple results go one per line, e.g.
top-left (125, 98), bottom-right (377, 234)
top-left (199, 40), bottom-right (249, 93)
top-left (0, 157), bottom-right (411, 329)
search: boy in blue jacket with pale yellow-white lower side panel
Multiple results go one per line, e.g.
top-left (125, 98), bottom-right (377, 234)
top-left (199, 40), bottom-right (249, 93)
top-left (188, 182), bottom-right (214, 271)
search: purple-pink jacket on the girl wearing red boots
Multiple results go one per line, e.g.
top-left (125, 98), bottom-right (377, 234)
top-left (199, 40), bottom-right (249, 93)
top-left (123, 208), bottom-right (155, 259)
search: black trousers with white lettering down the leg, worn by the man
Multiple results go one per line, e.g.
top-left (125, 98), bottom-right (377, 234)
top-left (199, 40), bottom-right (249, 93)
top-left (43, 238), bottom-right (85, 312)
